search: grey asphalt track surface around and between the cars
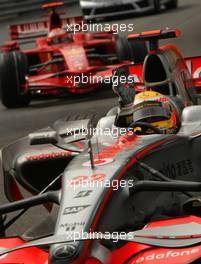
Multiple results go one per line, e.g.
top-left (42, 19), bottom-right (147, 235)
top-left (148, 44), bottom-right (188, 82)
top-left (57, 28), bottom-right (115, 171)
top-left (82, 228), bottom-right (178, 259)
top-left (0, 0), bottom-right (201, 235)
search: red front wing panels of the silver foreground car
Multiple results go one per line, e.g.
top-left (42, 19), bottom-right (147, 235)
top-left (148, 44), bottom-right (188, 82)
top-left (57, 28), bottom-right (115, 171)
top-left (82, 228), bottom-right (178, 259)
top-left (0, 216), bottom-right (201, 264)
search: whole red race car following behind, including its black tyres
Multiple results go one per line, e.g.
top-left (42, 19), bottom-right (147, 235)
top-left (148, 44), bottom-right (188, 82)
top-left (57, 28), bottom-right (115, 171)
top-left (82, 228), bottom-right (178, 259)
top-left (0, 2), bottom-right (147, 108)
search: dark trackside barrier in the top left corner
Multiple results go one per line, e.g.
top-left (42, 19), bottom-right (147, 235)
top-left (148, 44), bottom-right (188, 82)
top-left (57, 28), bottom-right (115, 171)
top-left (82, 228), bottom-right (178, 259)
top-left (0, 0), bottom-right (79, 19)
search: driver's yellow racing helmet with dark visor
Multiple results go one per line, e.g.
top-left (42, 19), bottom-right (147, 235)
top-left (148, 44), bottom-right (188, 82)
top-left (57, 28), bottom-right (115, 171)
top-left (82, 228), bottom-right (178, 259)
top-left (133, 91), bottom-right (178, 134)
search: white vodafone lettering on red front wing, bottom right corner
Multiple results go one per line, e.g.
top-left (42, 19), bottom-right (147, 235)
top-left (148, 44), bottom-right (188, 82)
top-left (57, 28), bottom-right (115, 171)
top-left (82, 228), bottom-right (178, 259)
top-left (131, 248), bottom-right (199, 264)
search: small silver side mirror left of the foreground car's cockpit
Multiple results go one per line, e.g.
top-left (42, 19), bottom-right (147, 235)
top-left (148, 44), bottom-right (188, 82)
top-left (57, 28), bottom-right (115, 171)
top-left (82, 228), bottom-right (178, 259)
top-left (29, 130), bottom-right (58, 145)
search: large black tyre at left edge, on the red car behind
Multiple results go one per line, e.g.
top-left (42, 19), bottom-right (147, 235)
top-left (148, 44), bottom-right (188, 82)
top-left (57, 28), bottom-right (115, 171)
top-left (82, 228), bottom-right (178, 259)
top-left (0, 51), bottom-right (30, 108)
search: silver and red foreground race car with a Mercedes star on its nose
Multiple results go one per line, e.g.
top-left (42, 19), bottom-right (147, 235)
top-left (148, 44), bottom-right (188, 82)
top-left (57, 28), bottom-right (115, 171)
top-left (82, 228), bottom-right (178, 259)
top-left (0, 29), bottom-right (201, 264)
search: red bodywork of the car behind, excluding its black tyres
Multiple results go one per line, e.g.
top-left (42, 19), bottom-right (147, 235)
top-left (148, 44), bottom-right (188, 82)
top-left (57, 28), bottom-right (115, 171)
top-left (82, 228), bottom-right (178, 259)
top-left (1, 2), bottom-right (126, 95)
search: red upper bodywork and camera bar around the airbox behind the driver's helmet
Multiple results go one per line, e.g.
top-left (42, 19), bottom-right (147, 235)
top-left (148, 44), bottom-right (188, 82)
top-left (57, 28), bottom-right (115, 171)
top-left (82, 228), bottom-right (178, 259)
top-left (128, 28), bottom-right (201, 94)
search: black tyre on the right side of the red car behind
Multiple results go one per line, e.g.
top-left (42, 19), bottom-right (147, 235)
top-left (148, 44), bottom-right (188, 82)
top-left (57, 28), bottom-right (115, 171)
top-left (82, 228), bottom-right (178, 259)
top-left (116, 36), bottom-right (148, 63)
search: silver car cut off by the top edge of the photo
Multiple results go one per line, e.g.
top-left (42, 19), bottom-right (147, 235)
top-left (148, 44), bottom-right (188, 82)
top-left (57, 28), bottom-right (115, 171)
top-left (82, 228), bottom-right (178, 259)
top-left (80, 0), bottom-right (178, 20)
